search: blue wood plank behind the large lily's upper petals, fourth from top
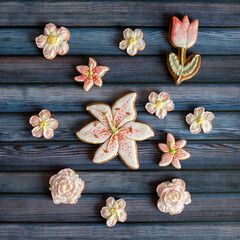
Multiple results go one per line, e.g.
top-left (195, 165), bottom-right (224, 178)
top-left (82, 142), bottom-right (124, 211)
top-left (0, 84), bottom-right (240, 114)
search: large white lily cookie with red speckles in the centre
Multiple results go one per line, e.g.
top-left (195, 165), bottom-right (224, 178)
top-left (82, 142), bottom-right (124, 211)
top-left (76, 92), bottom-right (154, 169)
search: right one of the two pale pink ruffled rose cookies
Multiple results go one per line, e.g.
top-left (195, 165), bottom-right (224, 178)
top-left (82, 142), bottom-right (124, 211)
top-left (157, 178), bottom-right (191, 215)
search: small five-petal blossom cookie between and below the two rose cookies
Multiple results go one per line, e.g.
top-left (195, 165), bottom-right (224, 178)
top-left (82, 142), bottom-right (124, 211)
top-left (101, 197), bottom-right (127, 227)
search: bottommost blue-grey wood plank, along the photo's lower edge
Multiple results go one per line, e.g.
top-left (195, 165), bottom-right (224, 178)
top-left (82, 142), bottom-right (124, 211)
top-left (0, 222), bottom-right (240, 240)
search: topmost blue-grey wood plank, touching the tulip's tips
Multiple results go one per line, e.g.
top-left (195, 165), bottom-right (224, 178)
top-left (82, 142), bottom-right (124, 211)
top-left (0, 1), bottom-right (240, 26)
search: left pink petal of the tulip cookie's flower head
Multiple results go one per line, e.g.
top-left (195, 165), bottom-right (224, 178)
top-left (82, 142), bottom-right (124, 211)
top-left (170, 17), bottom-right (187, 48)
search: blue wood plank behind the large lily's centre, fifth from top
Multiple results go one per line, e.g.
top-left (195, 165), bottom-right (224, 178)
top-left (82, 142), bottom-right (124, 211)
top-left (0, 112), bottom-right (240, 142)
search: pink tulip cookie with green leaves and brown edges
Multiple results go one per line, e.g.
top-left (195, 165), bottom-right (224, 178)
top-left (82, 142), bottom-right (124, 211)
top-left (167, 15), bottom-right (201, 85)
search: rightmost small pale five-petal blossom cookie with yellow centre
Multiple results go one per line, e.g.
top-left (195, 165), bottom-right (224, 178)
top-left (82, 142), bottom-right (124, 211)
top-left (186, 107), bottom-right (214, 134)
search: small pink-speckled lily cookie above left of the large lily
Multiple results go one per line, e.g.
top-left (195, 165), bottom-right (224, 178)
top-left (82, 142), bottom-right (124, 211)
top-left (74, 58), bottom-right (110, 92)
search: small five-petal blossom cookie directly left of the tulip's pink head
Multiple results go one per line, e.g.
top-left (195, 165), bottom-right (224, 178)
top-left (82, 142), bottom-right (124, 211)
top-left (119, 28), bottom-right (146, 56)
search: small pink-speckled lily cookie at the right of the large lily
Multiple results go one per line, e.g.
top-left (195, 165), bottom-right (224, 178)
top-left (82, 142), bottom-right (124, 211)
top-left (158, 133), bottom-right (191, 169)
